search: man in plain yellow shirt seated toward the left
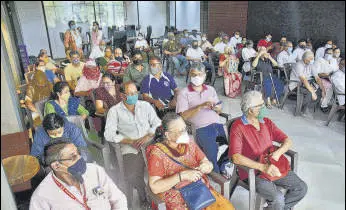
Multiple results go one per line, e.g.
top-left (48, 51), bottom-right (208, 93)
top-left (64, 51), bottom-right (84, 91)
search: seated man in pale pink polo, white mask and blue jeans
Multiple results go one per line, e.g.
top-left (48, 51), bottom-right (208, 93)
top-left (176, 63), bottom-right (226, 173)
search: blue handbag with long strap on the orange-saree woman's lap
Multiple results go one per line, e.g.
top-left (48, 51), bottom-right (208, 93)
top-left (160, 145), bottom-right (216, 210)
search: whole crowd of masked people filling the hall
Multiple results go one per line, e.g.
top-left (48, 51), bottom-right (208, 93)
top-left (18, 21), bottom-right (345, 210)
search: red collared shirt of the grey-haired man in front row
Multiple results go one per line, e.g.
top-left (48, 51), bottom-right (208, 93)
top-left (228, 115), bottom-right (287, 180)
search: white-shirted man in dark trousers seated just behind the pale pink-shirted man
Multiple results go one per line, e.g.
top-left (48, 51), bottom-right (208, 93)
top-left (186, 40), bottom-right (215, 83)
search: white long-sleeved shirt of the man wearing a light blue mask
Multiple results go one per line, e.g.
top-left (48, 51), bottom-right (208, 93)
top-left (104, 100), bottom-right (161, 155)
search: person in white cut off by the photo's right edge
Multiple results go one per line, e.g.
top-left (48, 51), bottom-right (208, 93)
top-left (330, 59), bottom-right (345, 106)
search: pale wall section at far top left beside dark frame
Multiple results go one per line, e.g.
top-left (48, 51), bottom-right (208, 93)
top-left (15, 1), bottom-right (50, 56)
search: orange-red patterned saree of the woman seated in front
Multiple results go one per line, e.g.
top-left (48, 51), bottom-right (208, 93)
top-left (146, 141), bottom-right (234, 210)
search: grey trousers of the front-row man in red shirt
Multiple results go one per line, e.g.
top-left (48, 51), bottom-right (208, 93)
top-left (255, 171), bottom-right (308, 210)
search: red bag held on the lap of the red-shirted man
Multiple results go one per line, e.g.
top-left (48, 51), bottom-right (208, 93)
top-left (259, 146), bottom-right (291, 181)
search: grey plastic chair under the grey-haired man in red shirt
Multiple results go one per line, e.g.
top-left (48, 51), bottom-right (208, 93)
top-left (228, 117), bottom-right (298, 210)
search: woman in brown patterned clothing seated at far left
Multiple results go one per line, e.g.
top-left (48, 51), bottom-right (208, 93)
top-left (25, 71), bottom-right (53, 127)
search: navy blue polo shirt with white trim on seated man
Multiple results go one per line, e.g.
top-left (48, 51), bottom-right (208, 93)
top-left (141, 72), bottom-right (177, 103)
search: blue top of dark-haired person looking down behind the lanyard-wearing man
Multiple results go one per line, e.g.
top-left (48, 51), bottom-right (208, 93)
top-left (30, 121), bottom-right (87, 160)
